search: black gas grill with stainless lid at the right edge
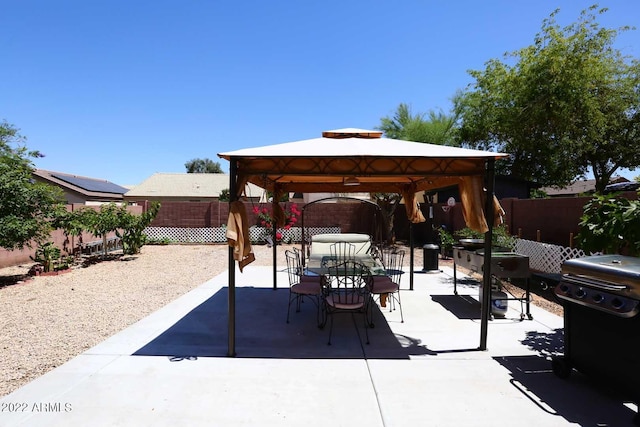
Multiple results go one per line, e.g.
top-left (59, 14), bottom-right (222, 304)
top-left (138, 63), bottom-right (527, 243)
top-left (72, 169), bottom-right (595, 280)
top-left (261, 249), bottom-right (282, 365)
top-left (553, 255), bottom-right (640, 422)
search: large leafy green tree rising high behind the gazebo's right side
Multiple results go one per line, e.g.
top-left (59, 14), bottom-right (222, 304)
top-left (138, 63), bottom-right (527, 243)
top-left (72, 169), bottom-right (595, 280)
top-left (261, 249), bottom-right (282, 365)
top-left (454, 5), bottom-right (640, 191)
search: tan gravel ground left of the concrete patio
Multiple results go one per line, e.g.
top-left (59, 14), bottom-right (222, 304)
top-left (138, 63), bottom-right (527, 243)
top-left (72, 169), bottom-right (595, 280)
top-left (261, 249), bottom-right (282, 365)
top-left (0, 245), bottom-right (557, 397)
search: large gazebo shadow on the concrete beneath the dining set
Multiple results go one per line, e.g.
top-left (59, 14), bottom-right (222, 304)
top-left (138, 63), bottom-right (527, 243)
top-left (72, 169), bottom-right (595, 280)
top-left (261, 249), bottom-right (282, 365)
top-left (133, 287), bottom-right (434, 360)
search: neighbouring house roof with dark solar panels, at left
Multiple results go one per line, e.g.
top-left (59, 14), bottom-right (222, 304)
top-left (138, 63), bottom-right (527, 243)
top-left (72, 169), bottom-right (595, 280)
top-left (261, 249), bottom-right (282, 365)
top-left (33, 169), bottom-right (129, 200)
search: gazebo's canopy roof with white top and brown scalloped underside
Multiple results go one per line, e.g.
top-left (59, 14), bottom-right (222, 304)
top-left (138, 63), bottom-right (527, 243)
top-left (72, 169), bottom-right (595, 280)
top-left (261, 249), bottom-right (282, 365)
top-left (218, 128), bottom-right (506, 193)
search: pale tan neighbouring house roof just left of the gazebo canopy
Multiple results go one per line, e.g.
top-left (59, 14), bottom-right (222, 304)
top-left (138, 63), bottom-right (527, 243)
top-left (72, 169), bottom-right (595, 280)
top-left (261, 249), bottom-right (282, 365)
top-left (125, 173), bottom-right (264, 199)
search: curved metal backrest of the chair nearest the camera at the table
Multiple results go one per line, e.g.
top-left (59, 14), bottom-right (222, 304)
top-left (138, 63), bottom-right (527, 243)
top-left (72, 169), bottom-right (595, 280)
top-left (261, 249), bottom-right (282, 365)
top-left (328, 260), bottom-right (373, 305)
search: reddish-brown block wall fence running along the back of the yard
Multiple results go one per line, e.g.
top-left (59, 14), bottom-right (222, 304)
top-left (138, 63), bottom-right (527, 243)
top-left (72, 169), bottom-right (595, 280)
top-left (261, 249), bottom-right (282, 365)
top-left (0, 192), bottom-right (638, 267)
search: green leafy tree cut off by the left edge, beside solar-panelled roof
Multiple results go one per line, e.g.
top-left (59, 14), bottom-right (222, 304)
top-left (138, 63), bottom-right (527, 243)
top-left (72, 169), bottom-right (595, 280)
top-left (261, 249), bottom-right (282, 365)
top-left (0, 121), bottom-right (63, 250)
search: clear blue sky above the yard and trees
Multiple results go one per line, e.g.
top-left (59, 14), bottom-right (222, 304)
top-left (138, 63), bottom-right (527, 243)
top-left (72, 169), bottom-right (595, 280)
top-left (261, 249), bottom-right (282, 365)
top-left (0, 0), bottom-right (640, 185)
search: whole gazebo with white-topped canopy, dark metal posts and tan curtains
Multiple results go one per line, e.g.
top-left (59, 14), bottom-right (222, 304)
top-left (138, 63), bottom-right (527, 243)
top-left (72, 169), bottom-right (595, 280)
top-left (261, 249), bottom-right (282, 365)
top-left (218, 128), bottom-right (507, 356)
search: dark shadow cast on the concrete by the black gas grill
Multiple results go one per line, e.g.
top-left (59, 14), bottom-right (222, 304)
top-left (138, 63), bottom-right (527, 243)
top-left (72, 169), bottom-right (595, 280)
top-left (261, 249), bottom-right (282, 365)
top-left (494, 354), bottom-right (636, 426)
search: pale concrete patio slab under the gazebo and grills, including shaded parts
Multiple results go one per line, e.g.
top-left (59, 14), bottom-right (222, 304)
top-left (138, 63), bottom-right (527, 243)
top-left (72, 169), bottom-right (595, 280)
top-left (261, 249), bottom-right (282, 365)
top-left (0, 266), bottom-right (637, 427)
